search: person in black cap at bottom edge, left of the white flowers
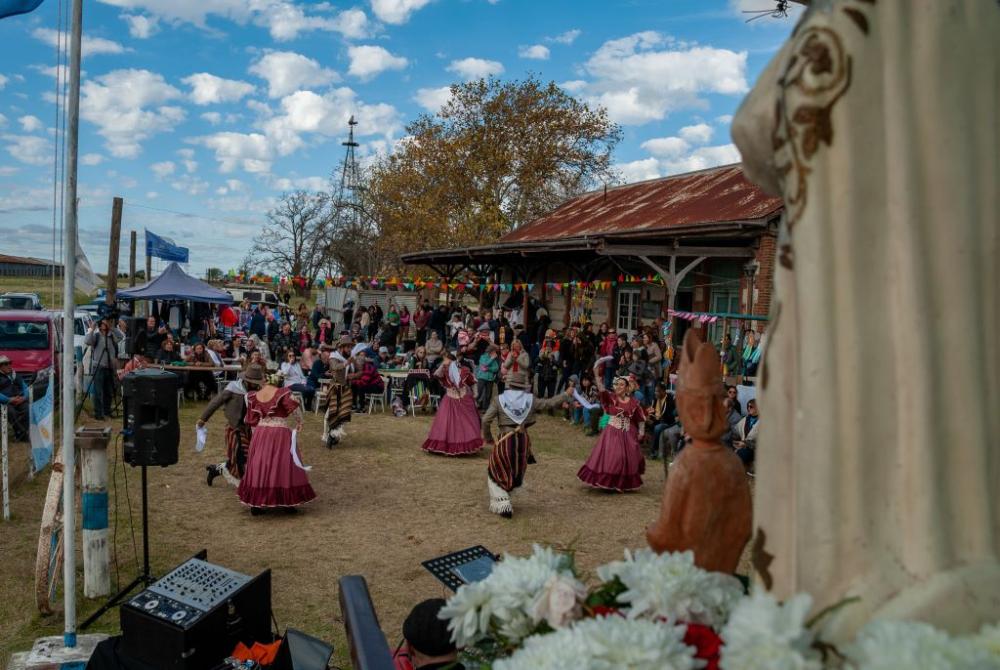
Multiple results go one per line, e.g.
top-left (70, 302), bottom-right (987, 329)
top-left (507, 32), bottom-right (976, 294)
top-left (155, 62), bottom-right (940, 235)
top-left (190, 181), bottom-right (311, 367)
top-left (392, 598), bottom-right (465, 670)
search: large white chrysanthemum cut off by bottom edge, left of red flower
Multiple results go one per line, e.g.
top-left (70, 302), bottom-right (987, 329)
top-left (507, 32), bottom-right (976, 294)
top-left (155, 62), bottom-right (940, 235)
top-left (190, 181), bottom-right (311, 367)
top-left (493, 616), bottom-right (702, 670)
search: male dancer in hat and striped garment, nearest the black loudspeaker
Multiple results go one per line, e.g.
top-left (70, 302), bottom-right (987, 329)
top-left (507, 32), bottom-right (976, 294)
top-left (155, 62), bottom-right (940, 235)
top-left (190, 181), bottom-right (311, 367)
top-left (198, 363), bottom-right (265, 486)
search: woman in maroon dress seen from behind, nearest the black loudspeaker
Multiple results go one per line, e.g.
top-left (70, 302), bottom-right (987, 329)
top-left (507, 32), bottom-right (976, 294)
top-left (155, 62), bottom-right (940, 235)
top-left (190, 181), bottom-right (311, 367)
top-left (237, 380), bottom-right (316, 514)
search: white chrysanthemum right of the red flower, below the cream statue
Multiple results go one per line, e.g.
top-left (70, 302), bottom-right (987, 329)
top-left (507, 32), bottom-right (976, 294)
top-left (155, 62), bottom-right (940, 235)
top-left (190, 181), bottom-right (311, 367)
top-left (720, 593), bottom-right (822, 670)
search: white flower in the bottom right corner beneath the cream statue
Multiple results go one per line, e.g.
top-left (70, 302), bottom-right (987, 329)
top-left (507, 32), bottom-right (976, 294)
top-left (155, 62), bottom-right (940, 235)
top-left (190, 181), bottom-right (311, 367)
top-left (844, 621), bottom-right (1000, 670)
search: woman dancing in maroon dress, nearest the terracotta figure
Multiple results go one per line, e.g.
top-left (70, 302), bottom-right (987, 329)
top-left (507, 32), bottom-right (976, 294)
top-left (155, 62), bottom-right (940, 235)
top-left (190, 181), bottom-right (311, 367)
top-left (576, 374), bottom-right (646, 492)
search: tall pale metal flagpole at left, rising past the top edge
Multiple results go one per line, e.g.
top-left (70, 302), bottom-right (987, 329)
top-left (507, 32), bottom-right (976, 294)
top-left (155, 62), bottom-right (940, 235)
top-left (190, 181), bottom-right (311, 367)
top-left (60, 0), bottom-right (83, 647)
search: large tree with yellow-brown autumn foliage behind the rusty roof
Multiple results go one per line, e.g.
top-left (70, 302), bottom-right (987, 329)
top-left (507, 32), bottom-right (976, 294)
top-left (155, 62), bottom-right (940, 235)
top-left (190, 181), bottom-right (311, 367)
top-left (365, 77), bottom-right (621, 268)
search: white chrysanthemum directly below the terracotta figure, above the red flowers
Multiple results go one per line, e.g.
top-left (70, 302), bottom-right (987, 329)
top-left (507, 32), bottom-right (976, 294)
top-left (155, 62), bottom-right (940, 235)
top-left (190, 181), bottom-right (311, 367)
top-left (597, 549), bottom-right (743, 629)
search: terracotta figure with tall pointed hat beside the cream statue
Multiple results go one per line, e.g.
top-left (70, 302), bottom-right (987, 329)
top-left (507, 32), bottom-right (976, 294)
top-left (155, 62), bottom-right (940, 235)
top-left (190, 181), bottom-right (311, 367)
top-left (646, 330), bottom-right (752, 574)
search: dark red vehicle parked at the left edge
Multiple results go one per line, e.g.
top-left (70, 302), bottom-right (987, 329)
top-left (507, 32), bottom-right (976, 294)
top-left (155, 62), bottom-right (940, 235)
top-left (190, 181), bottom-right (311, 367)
top-left (0, 310), bottom-right (61, 397)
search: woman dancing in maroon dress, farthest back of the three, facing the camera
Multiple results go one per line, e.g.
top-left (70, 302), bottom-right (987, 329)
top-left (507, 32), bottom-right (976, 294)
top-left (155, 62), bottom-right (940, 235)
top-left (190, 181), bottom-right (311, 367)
top-left (423, 355), bottom-right (483, 456)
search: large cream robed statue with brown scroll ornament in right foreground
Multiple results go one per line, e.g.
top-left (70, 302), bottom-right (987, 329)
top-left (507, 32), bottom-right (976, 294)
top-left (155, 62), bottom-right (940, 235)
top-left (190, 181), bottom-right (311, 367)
top-left (733, 0), bottom-right (1000, 641)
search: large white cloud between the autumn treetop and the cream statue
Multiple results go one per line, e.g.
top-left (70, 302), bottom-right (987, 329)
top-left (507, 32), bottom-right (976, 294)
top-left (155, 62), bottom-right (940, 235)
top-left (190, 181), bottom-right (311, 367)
top-left (582, 31), bottom-right (748, 125)
